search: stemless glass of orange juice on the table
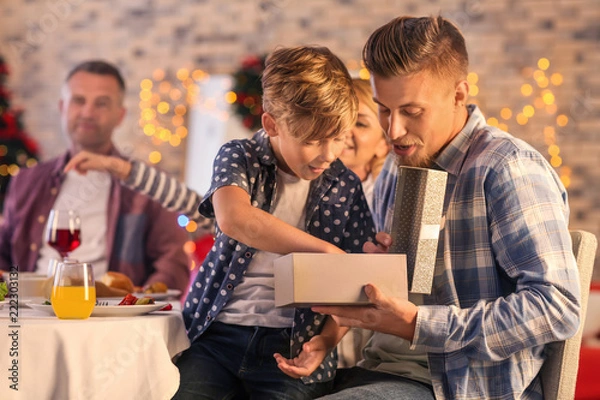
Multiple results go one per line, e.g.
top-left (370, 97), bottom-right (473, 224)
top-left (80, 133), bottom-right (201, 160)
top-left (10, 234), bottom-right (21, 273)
top-left (50, 260), bottom-right (96, 319)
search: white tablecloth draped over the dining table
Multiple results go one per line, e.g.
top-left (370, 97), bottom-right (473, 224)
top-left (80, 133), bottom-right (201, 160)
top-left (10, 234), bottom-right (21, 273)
top-left (0, 305), bottom-right (189, 400)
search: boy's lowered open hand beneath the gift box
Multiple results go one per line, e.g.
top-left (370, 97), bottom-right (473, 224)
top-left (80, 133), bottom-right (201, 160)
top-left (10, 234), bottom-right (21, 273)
top-left (273, 335), bottom-right (331, 379)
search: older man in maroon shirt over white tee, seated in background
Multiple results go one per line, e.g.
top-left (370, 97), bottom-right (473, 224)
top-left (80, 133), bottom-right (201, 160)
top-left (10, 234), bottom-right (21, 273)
top-left (0, 61), bottom-right (189, 290)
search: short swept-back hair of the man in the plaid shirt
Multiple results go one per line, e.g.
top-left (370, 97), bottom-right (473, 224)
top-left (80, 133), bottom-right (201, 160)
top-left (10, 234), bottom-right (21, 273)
top-left (363, 16), bottom-right (469, 83)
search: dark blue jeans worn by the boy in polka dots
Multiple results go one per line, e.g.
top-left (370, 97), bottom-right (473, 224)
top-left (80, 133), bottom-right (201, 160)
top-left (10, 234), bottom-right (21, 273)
top-left (173, 321), bottom-right (333, 400)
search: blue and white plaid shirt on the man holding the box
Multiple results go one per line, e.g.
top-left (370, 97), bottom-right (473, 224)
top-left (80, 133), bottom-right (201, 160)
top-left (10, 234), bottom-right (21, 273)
top-left (374, 105), bottom-right (580, 399)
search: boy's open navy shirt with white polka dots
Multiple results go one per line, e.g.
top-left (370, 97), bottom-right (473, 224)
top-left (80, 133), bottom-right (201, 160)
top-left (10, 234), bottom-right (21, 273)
top-left (183, 130), bottom-right (375, 383)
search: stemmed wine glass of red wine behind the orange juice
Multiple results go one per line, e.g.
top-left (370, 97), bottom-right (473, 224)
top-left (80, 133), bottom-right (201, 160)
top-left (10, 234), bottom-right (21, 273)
top-left (46, 209), bottom-right (81, 260)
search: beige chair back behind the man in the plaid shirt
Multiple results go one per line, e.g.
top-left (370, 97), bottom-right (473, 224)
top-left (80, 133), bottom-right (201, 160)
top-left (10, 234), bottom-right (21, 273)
top-left (540, 231), bottom-right (598, 400)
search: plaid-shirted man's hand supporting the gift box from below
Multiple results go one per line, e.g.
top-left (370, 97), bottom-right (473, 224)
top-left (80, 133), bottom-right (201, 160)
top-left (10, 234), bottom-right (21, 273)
top-left (312, 282), bottom-right (419, 342)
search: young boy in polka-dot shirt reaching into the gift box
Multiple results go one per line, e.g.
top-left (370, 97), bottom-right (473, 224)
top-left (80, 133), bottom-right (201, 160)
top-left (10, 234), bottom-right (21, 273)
top-left (175, 47), bottom-right (374, 399)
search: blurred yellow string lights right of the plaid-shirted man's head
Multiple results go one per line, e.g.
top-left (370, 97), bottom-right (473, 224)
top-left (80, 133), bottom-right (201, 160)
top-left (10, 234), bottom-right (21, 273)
top-left (467, 58), bottom-right (572, 188)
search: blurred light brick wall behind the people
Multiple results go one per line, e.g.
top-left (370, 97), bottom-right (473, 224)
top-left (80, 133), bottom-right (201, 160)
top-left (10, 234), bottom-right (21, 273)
top-left (0, 0), bottom-right (600, 279)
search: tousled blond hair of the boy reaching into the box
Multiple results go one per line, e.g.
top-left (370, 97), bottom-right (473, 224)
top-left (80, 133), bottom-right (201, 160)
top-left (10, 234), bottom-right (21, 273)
top-left (262, 46), bottom-right (358, 141)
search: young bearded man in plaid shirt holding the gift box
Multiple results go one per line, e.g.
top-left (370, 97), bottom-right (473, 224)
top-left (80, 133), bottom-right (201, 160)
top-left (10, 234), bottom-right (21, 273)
top-left (302, 17), bottom-right (580, 400)
